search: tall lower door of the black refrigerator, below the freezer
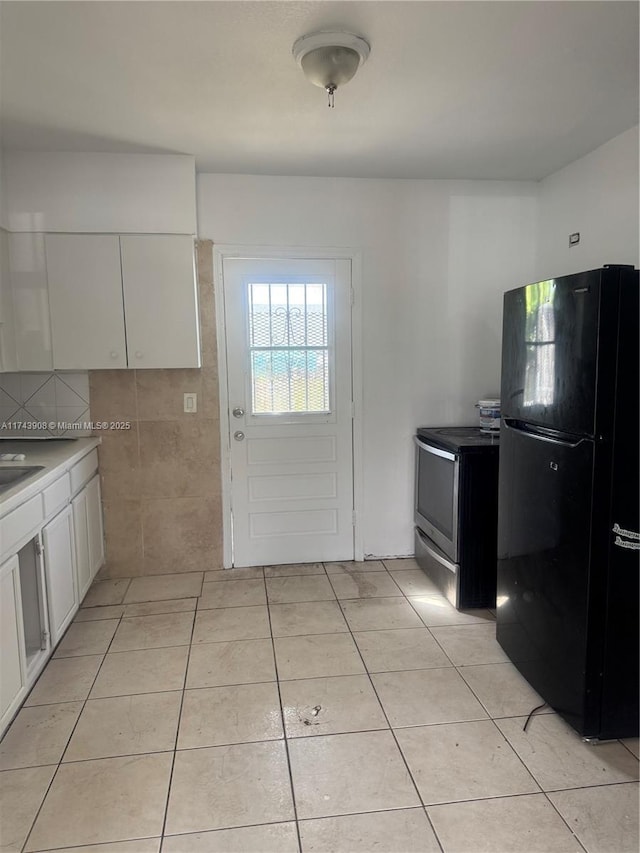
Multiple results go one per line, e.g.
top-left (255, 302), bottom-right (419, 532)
top-left (497, 425), bottom-right (594, 730)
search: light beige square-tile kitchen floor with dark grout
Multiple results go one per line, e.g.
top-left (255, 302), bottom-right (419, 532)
top-left (0, 559), bottom-right (638, 853)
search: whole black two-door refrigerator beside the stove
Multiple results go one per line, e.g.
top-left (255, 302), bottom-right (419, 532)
top-left (497, 265), bottom-right (640, 740)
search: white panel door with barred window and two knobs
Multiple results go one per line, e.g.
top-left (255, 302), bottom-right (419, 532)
top-left (223, 258), bottom-right (354, 566)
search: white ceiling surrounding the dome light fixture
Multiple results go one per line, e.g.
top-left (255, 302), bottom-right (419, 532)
top-left (0, 0), bottom-right (638, 179)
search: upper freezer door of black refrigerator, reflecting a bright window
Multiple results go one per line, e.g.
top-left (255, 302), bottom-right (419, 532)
top-left (501, 270), bottom-right (601, 435)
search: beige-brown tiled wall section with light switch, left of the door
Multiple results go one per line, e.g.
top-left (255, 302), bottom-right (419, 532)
top-left (89, 240), bottom-right (222, 578)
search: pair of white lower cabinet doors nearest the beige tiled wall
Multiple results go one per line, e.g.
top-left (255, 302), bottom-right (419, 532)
top-left (71, 474), bottom-right (104, 601)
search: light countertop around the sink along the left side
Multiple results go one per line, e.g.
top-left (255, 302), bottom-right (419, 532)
top-left (0, 436), bottom-right (101, 516)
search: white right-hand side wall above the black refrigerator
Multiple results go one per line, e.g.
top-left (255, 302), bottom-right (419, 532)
top-left (535, 126), bottom-right (640, 279)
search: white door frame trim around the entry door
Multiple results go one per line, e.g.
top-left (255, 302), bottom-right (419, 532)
top-left (213, 243), bottom-right (364, 569)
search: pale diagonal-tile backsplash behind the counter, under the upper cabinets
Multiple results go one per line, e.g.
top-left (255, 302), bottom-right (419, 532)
top-left (0, 371), bottom-right (91, 438)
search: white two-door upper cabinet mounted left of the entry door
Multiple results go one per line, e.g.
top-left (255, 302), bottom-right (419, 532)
top-left (46, 234), bottom-right (200, 370)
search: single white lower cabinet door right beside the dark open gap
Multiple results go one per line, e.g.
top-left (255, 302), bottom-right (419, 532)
top-left (42, 506), bottom-right (78, 645)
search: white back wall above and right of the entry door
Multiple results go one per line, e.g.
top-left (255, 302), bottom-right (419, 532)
top-left (197, 174), bottom-right (537, 556)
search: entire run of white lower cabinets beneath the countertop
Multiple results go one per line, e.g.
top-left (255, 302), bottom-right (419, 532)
top-left (0, 450), bottom-right (104, 740)
